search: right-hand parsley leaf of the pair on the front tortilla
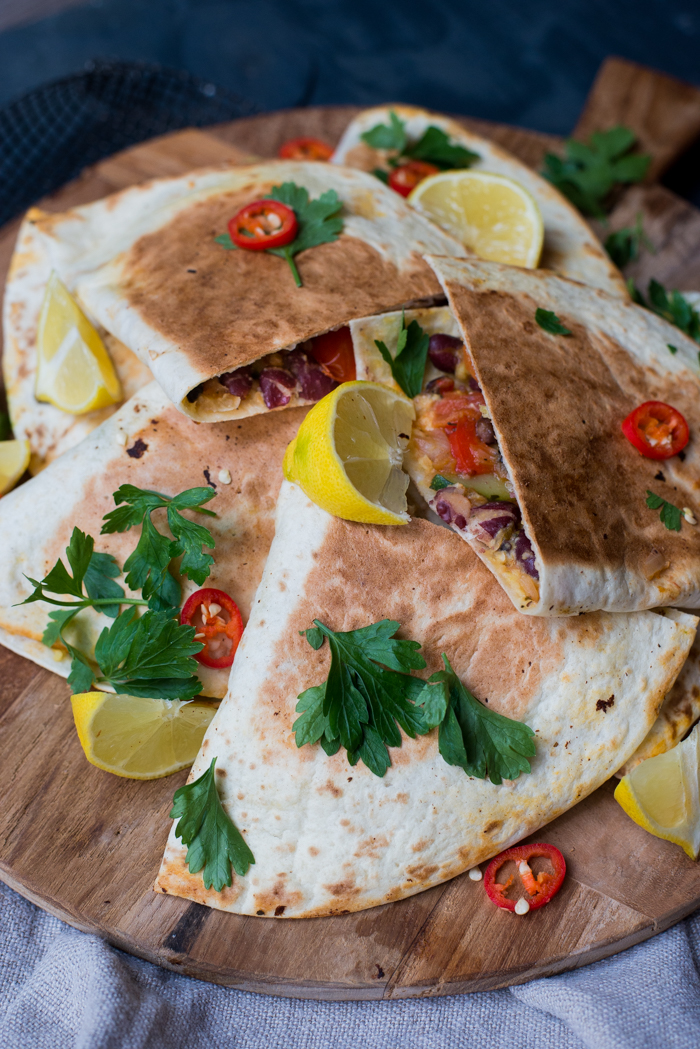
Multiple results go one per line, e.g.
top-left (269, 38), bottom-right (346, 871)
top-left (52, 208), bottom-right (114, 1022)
top-left (424, 654), bottom-right (535, 784)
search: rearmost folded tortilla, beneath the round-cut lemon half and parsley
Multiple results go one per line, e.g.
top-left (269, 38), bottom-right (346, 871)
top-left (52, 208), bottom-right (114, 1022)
top-left (332, 105), bottom-right (628, 299)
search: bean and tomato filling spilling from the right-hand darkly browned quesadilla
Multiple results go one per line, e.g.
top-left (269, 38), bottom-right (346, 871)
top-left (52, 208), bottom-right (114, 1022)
top-left (409, 335), bottom-right (539, 604)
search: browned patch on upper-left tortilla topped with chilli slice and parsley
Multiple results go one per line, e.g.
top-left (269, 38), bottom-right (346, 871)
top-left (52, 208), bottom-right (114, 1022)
top-left (123, 184), bottom-right (440, 374)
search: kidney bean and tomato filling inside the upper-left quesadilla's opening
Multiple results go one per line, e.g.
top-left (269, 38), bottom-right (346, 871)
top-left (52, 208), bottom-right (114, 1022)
top-left (187, 327), bottom-right (356, 414)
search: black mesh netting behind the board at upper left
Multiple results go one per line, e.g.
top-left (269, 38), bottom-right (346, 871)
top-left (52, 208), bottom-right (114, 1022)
top-left (0, 62), bottom-right (256, 226)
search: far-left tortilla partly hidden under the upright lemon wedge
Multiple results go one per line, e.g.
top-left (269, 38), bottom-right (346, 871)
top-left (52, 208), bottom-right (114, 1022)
top-left (2, 208), bottom-right (153, 473)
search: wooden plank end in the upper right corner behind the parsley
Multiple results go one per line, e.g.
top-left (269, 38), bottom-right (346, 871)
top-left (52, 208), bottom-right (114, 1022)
top-left (573, 58), bottom-right (700, 183)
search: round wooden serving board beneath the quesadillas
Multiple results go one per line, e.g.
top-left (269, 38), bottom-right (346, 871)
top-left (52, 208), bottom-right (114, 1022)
top-left (0, 98), bottom-right (700, 1000)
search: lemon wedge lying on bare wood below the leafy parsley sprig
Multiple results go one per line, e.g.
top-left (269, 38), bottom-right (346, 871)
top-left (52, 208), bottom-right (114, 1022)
top-left (70, 692), bottom-right (216, 779)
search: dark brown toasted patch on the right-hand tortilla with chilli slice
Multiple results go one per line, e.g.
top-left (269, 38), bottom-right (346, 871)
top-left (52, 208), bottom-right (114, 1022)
top-left (448, 282), bottom-right (700, 587)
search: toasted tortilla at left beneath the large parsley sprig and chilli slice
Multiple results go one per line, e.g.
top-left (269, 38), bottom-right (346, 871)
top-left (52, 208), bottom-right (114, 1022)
top-left (0, 383), bottom-right (304, 699)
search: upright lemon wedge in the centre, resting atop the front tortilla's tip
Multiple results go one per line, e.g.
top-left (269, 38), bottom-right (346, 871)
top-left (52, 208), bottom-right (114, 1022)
top-left (284, 381), bottom-right (416, 525)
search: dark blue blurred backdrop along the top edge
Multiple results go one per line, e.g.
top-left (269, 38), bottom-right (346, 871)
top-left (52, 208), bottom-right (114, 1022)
top-left (0, 0), bottom-right (700, 133)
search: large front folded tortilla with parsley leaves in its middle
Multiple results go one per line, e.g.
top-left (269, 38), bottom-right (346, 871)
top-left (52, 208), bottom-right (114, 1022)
top-left (154, 483), bottom-right (698, 918)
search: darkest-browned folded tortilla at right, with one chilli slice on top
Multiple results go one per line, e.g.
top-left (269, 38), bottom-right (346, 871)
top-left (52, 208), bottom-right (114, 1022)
top-left (413, 258), bottom-right (700, 616)
